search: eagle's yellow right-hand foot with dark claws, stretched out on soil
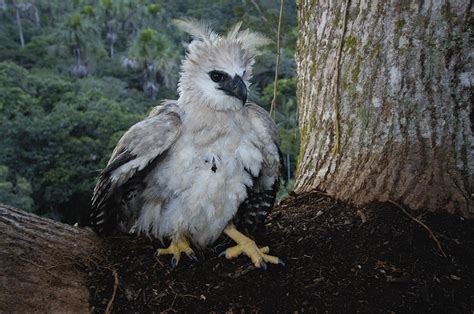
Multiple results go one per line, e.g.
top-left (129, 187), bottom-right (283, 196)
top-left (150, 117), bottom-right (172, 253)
top-left (221, 225), bottom-right (285, 269)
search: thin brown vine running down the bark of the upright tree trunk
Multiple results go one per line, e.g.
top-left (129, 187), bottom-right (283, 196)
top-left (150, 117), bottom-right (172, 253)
top-left (333, 0), bottom-right (351, 154)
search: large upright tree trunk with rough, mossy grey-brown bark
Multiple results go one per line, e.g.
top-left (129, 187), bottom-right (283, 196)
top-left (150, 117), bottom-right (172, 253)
top-left (296, 0), bottom-right (474, 216)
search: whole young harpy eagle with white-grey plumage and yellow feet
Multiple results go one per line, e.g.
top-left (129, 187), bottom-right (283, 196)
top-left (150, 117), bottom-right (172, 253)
top-left (91, 20), bottom-right (283, 268)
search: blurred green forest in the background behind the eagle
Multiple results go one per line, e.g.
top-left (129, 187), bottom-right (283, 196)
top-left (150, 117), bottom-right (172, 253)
top-left (0, 0), bottom-right (299, 223)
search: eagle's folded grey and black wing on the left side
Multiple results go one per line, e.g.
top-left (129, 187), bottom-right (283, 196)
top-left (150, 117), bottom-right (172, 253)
top-left (90, 102), bottom-right (181, 231)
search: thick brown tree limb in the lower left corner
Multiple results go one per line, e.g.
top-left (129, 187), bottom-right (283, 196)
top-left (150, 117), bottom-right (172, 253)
top-left (0, 205), bottom-right (101, 313)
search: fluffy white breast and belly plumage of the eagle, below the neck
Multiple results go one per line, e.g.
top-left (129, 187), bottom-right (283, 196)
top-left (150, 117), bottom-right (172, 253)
top-left (138, 109), bottom-right (262, 246)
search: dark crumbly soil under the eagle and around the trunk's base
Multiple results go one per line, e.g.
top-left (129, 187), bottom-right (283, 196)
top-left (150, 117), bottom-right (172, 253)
top-left (89, 193), bottom-right (474, 313)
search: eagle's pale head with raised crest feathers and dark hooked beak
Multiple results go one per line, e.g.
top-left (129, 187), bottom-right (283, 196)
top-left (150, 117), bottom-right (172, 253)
top-left (176, 19), bottom-right (269, 111)
